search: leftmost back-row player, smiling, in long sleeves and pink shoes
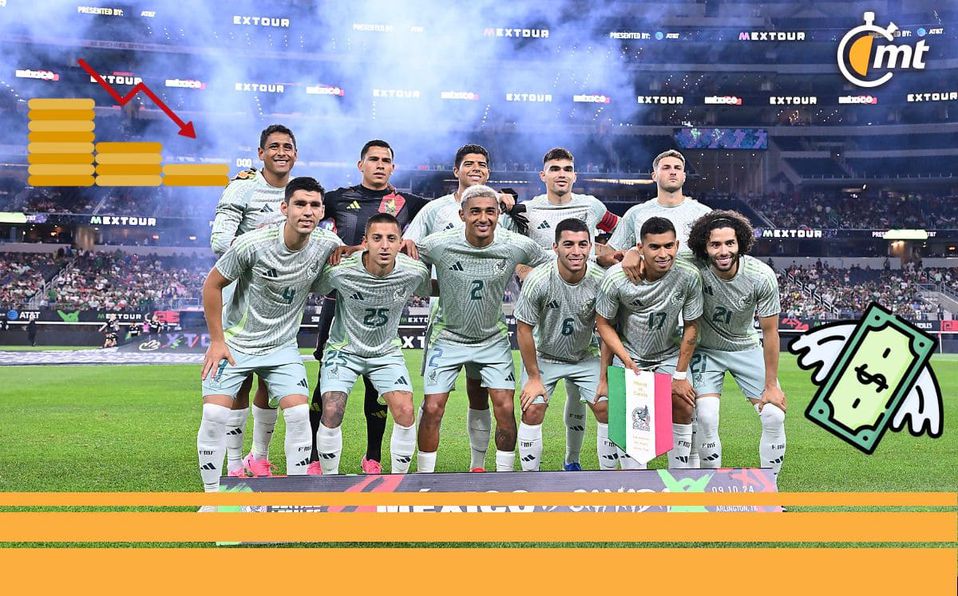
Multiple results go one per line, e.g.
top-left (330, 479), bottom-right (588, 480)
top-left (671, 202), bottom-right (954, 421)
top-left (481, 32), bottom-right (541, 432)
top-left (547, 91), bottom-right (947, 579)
top-left (210, 124), bottom-right (296, 476)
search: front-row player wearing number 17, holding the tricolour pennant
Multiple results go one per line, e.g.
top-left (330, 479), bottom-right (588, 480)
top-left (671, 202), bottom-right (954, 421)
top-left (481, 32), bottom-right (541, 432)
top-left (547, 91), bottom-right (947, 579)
top-left (595, 217), bottom-right (702, 468)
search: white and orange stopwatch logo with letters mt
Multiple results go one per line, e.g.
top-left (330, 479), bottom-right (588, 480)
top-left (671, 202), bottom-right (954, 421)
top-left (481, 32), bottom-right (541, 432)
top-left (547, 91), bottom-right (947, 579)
top-left (838, 12), bottom-right (928, 88)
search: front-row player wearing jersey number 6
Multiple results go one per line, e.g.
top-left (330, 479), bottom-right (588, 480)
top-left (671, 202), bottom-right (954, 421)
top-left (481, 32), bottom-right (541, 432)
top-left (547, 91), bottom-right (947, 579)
top-left (515, 218), bottom-right (618, 471)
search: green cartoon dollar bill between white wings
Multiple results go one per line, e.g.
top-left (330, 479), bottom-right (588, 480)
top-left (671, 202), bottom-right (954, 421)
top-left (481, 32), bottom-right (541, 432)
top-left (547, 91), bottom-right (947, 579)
top-left (796, 303), bottom-right (935, 453)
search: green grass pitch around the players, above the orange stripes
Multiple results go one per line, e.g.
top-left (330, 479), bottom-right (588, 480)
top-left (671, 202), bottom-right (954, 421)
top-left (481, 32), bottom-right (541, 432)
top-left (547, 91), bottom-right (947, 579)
top-left (0, 350), bottom-right (958, 491)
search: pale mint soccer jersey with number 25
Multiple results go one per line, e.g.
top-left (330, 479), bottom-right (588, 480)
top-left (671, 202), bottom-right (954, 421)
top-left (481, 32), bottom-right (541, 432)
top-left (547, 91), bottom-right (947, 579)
top-left (319, 251), bottom-right (432, 358)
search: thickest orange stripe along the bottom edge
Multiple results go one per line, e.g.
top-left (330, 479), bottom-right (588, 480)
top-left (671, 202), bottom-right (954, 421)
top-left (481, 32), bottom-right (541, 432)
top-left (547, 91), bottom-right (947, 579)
top-left (0, 548), bottom-right (956, 596)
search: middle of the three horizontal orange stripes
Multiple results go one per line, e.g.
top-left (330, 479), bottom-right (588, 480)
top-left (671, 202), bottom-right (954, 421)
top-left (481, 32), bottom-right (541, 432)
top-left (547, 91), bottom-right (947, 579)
top-left (0, 508), bottom-right (958, 543)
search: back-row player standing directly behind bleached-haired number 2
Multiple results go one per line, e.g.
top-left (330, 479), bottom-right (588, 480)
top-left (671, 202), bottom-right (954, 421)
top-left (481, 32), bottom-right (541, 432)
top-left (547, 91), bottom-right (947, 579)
top-left (403, 145), bottom-right (515, 472)
